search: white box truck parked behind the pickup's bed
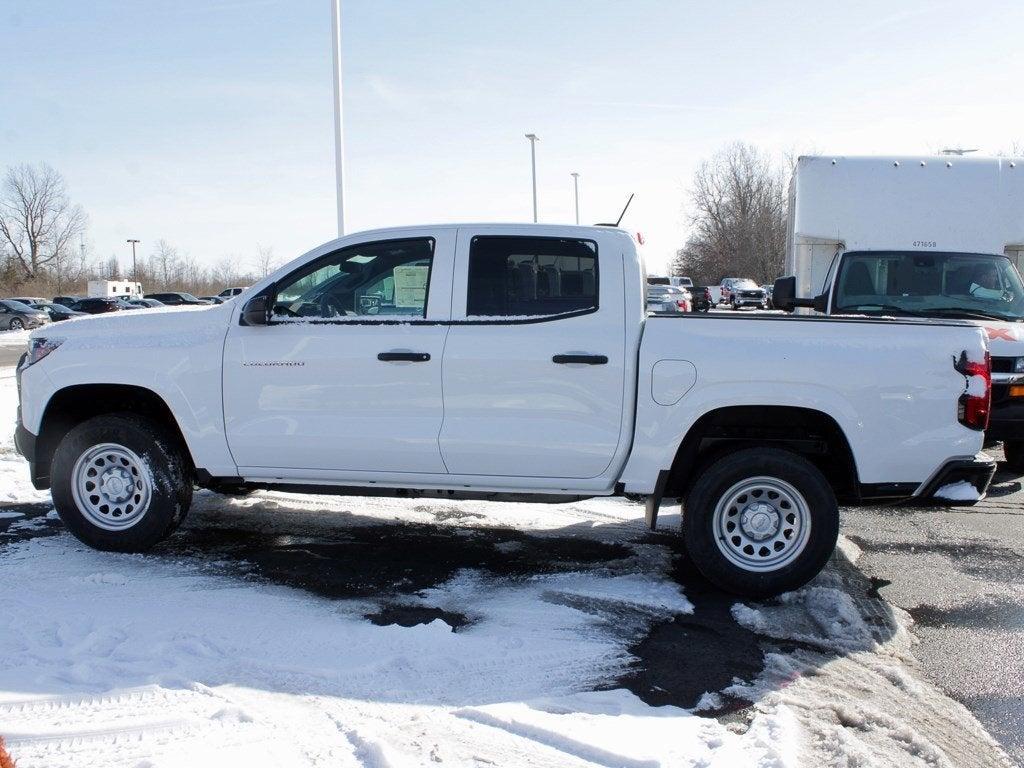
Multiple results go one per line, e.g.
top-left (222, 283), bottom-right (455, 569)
top-left (774, 156), bottom-right (1024, 472)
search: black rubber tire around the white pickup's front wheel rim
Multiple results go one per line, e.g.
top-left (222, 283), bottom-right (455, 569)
top-left (50, 414), bottom-right (193, 552)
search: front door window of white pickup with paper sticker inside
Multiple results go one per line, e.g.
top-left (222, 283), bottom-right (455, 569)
top-left (273, 238), bottom-right (434, 319)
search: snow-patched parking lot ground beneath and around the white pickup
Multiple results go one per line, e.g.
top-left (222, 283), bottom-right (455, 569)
top-left (0, 345), bottom-right (1024, 768)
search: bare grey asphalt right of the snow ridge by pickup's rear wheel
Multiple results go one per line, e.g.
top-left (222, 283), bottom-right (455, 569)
top-left (843, 450), bottom-right (1024, 765)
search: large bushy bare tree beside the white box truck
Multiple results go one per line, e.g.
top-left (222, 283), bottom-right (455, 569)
top-left (672, 142), bottom-right (786, 283)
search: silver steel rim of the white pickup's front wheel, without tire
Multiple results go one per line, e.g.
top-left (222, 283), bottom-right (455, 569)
top-left (72, 442), bottom-right (153, 530)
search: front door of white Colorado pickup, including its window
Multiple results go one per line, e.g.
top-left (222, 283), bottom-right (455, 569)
top-left (223, 229), bottom-right (455, 479)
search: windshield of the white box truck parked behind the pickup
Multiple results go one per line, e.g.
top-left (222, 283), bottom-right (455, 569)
top-left (833, 251), bottom-right (1024, 321)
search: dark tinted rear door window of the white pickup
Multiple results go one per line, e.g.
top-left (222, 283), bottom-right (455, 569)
top-left (466, 236), bottom-right (597, 317)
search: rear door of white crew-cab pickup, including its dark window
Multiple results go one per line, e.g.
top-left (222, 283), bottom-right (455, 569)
top-left (440, 226), bottom-right (632, 478)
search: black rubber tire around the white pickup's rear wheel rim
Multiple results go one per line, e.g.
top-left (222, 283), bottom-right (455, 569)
top-left (682, 447), bottom-right (839, 598)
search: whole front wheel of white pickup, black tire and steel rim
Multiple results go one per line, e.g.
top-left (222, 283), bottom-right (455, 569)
top-left (50, 414), bottom-right (191, 552)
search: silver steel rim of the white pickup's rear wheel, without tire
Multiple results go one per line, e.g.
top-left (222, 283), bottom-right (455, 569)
top-left (712, 476), bottom-right (811, 572)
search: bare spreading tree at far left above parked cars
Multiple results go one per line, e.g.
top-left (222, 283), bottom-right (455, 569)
top-left (0, 163), bottom-right (86, 280)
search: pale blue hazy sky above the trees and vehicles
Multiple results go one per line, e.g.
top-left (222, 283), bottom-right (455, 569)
top-left (0, 0), bottom-right (1024, 276)
